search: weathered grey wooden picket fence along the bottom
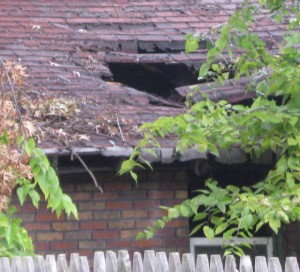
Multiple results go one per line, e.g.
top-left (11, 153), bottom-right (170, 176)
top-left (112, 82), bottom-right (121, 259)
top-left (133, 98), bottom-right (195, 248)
top-left (0, 250), bottom-right (300, 272)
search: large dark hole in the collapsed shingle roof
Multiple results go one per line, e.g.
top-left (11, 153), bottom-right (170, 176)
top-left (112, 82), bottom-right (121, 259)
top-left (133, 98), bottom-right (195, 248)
top-left (103, 62), bottom-right (199, 100)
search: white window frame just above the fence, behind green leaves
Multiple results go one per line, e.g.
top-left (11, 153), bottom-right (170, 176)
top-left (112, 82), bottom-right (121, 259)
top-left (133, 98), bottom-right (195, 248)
top-left (190, 237), bottom-right (273, 258)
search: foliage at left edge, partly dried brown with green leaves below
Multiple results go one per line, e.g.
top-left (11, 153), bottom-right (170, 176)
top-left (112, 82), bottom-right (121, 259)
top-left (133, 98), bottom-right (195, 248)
top-left (0, 61), bottom-right (77, 256)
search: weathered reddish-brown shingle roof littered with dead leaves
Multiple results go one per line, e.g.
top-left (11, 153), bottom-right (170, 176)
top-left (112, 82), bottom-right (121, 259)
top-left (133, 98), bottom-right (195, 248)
top-left (0, 0), bottom-right (284, 162)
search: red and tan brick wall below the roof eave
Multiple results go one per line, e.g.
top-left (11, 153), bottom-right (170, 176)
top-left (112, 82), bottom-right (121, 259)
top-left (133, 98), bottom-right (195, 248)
top-left (12, 167), bottom-right (189, 257)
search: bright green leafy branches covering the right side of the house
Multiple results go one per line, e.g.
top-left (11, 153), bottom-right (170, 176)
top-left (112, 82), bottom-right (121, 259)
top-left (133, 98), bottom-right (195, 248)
top-left (121, 0), bottom-right (300, 255)
